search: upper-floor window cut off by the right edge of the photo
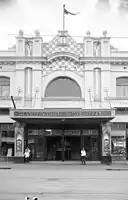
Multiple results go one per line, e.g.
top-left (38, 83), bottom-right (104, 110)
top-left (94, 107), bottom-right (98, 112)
top-left (116, 77), bottom-right (128, 97)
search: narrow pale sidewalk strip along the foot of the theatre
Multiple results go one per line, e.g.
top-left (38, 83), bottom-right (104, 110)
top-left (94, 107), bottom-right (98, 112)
top-left (0, 161), bottom-right (128, 171)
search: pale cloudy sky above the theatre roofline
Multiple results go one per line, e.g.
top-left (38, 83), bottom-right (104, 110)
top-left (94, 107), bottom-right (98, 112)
top-left (0, 0), bottom-right (128, 50)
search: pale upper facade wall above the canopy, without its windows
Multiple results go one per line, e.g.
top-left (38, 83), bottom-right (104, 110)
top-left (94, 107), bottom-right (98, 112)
top-left (0, 31), bottom-right (128, 161)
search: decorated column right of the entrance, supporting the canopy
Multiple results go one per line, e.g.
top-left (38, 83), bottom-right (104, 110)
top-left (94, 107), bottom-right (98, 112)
top-left (101, 123), bottom-right (111, 163)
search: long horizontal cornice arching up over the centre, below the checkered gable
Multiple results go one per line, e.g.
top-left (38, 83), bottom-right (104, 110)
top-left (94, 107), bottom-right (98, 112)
top-left (0, 55), bottom-right (128, 65)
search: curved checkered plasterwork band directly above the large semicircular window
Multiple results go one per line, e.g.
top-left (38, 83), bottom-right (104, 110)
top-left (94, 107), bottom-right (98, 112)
top-left (42, 56), bottom-right (84, 76)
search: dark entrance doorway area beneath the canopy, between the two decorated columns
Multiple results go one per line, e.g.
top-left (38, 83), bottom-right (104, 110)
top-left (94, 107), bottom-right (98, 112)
top-left (28, 129), bottom-right (100, 161)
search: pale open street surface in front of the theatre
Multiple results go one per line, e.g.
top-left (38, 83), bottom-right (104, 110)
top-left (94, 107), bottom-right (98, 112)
top-left (0, 162), bottom-right (128, 200)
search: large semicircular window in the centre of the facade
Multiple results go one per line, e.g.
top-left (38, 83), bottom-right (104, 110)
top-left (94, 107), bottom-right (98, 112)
top-left (45, 77), bottom-right (81, 97)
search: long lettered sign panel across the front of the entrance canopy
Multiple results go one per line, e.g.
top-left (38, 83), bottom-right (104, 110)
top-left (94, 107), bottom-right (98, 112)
top-left (10, 109), bottom-right (113, 119)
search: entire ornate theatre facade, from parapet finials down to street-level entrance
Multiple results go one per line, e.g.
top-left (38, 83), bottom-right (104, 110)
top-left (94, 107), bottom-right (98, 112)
top-left (0, 30), bottom-right (128, 162)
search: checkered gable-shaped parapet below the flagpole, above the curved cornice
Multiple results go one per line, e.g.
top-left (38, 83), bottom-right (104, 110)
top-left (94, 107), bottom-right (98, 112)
top-left (42, 31), bottom-right (84, 57)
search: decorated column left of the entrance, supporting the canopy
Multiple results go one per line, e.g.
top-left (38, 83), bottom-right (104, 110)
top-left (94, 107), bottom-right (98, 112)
top-left (14, 122), bottom-right (24, 163)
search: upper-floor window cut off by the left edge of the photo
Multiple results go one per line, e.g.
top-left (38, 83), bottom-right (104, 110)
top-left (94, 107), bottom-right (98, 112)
top-left (0, 76), bottom-right (10, 97)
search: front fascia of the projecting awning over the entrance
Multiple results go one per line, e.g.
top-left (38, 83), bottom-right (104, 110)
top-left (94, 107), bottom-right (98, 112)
top-left (10, 108), bottom-right (115, 119)
